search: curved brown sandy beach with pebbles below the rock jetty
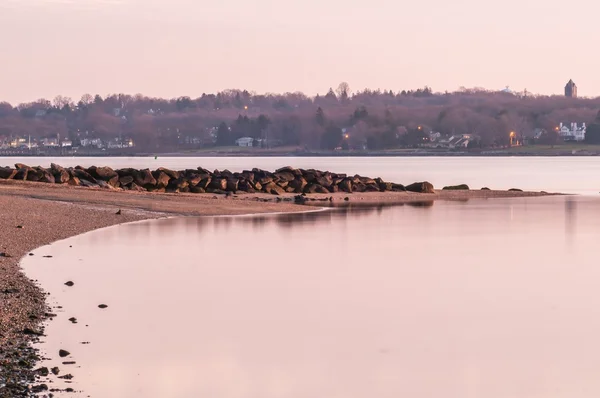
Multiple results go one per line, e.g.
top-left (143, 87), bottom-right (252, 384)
top-left (0, 180), bottom-right (553, 398)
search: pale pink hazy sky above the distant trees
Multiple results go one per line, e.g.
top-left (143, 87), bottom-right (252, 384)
top-left (0, 0), bottom-right (600, 104)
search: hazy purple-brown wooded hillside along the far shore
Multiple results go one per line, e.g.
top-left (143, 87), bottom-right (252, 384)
top-left (0, 83), bottom-right (600, 150)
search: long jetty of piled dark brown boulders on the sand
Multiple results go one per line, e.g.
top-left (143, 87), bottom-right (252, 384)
top-left (0, 163), bottom-right (434, 195)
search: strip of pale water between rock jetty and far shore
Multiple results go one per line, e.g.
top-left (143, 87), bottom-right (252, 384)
top-left (0, 157), bottom-right (600, 195)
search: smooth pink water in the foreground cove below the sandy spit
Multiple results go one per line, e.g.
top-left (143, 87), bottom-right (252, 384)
top-left (23, 197), bottom-right (600, 398)
